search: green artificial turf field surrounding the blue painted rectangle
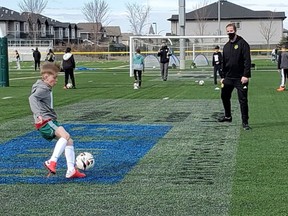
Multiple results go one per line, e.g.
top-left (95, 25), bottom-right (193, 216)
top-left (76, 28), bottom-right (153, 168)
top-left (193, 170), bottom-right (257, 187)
top-left (0, 60), bottom-right (288, 216)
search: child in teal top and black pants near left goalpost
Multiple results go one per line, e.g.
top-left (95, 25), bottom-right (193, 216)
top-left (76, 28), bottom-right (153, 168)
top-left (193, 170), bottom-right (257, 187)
top-left (133, 48), bottom-right (144, 89)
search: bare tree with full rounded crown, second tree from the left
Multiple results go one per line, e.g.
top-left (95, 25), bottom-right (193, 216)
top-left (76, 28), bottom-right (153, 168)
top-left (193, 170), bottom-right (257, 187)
top-left (82, 0), bottom-right (109, 44)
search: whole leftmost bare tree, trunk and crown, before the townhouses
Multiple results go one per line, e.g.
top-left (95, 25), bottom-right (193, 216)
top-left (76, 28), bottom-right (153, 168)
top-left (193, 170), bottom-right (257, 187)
top-left (18, 0), bottom-right (48, 40)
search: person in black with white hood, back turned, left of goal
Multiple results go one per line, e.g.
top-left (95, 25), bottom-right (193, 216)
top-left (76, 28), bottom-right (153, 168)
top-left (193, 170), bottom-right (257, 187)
top-left (62, 47), bottom-right (76, 89)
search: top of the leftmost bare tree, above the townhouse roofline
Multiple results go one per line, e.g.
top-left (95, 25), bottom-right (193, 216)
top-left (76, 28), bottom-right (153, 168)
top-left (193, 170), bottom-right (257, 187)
top-left (18, 0), bottom-right (48, 14)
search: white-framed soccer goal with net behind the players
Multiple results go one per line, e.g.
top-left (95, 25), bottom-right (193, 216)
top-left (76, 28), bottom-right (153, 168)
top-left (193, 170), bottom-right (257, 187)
top-left (129, 35), bottom-right (227, 77)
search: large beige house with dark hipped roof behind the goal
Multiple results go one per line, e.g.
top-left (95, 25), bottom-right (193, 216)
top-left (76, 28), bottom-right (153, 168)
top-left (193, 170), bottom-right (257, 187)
top-left (168, 0), bottom-right (286, 45)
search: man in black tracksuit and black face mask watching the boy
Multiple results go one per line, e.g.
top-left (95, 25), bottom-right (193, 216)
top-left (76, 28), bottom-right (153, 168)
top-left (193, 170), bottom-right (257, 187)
top-left (219, 23), bottom-right (251, 130)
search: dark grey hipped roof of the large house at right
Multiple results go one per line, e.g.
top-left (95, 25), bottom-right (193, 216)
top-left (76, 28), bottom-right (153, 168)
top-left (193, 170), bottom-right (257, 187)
top-left (168, 0), bottom-right (286, 21)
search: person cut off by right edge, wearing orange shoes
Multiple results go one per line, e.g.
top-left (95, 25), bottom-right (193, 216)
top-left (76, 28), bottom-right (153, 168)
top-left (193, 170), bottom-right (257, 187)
top-left (277, 45), bottom-right (288, 92)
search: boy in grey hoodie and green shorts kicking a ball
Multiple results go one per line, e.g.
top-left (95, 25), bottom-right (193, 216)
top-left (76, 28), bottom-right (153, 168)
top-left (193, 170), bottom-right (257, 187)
top-left (29, 62), bottom-right (86, 178)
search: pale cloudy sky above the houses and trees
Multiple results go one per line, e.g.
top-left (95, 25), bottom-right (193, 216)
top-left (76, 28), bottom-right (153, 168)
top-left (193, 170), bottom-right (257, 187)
top-left (0, 0), bottom-right (288, 34)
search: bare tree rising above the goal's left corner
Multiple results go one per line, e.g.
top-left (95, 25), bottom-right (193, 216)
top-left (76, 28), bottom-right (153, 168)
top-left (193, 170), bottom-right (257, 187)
top-left (126, 3), bottom-right (151, 35)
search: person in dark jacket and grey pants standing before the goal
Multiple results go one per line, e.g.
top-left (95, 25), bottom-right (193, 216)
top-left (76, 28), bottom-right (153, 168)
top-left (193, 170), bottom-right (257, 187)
top-left (157, 41), bottom-right (172, 81)
